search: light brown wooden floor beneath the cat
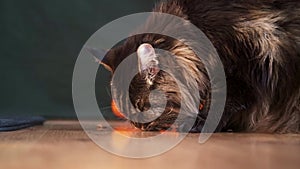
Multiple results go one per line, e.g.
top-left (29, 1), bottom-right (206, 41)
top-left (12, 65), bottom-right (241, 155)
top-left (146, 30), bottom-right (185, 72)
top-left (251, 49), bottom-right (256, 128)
top-left (0, 121), bottom-right (300, 169)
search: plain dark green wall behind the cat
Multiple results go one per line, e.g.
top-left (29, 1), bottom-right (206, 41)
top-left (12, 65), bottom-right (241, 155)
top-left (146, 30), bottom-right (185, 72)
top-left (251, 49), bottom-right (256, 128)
top-left (0, 0), bottom-right (155, 118)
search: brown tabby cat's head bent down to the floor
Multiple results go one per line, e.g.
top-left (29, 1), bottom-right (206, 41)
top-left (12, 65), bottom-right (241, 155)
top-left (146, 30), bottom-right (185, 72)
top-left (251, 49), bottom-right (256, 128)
top-left (96, 37), bottom-right (208, 131)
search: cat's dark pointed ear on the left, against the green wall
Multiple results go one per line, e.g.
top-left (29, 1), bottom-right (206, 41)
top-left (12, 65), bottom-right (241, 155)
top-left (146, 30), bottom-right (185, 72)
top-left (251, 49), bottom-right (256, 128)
top-left (85, 47), bottom-right (113, 72)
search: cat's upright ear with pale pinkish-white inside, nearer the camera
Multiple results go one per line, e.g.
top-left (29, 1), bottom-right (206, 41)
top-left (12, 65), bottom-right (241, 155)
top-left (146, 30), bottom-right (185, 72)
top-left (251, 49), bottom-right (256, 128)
top-left (137, 43), bottom-right (160, 77)
